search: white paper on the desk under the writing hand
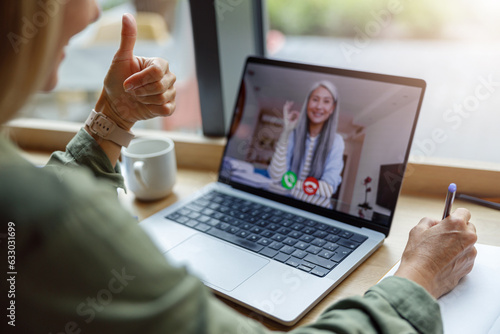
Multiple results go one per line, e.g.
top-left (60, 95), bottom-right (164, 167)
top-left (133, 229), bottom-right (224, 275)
top-left (384, 244), bottom-right (500, 334)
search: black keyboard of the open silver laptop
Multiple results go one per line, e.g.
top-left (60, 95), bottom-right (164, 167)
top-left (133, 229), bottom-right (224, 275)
top-left (165, 191), bottom-right (367, 277)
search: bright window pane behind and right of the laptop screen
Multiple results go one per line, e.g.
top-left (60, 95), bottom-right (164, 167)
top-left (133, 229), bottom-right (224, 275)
top-left (266, 0), bottom-right (500, 166)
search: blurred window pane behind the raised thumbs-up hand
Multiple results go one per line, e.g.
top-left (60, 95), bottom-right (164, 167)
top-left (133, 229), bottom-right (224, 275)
top-left (14, 0), bottom-right (201, 133)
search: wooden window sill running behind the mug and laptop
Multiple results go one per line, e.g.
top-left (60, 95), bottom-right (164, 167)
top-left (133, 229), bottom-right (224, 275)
top-left (5, 119), bottom-right (500, 202)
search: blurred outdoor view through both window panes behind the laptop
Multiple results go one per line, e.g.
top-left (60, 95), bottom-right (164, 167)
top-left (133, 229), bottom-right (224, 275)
top-left (14, 0), bottom-right (500, 163)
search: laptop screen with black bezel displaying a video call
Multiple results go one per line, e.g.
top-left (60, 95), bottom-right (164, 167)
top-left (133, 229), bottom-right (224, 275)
top-left (219, 57), bottom-right (425, 234)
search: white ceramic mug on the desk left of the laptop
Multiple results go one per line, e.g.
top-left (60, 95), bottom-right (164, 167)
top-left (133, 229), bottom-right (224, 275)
top-left (122, 138), bottom-right (177, 201)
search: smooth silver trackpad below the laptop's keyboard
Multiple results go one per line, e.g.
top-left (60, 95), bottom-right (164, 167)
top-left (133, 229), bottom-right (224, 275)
top-left (165, 234), bottom-right (269, 291)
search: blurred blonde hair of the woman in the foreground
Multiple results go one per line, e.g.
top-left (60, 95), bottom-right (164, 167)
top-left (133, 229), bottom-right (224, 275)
top-left (0, 0), bottom-right (63, 125)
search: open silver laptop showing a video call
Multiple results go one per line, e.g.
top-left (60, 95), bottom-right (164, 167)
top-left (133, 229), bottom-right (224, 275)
top-left (140, 57), bottom-right (425, 325)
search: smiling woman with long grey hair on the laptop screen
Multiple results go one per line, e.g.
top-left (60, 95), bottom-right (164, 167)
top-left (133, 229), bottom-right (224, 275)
top-left (268, 80), bottom-right (344, 206)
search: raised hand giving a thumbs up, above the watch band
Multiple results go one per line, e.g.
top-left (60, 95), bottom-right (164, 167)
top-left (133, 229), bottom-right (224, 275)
top-left (95, 14), bottom-right (176, 130)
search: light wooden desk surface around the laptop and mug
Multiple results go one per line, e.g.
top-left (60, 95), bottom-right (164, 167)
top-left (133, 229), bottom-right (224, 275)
top-left (120, 169), bottom-right (500, 331)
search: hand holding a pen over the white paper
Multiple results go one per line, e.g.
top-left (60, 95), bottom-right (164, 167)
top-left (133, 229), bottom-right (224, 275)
top-left (394, 183), bottom-right (477, 298)
